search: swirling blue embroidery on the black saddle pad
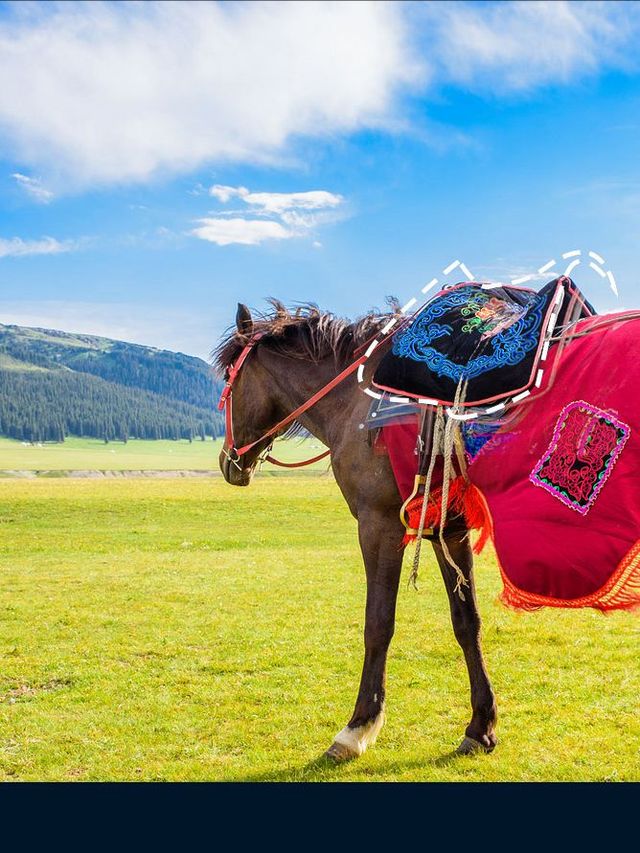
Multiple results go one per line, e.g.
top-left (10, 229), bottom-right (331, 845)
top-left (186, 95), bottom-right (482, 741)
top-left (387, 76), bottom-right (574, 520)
top-left (393, 287), bottom-right (545, 382)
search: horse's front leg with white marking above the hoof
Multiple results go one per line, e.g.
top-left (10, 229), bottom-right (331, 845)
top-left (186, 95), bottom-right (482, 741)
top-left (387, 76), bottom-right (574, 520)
top-left (325, 512), bottom-right (403, 761)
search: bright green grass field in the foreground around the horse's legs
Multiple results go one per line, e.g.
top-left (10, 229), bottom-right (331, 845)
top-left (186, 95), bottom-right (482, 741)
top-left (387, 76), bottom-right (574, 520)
top-left (0, 476), bottom-right (640, 781)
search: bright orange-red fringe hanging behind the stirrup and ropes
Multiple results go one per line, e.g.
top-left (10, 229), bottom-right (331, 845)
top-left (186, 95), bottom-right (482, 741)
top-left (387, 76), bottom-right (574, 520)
top-left (402, 476), bottom-right (491, 554)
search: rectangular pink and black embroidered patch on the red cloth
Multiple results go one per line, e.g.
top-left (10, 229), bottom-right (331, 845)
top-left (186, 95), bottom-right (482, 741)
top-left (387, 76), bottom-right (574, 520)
top-left (529, 400), bottom-right (631, 515)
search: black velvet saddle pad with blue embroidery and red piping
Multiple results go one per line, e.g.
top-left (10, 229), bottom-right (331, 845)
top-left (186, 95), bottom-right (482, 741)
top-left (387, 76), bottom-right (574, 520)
top-left (373, 276), bottom-right (595, 406)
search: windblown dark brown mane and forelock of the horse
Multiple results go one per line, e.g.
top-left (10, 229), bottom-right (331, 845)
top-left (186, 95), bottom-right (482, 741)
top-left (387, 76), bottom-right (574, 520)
top-left (211, 298), bottom-right (398, 374)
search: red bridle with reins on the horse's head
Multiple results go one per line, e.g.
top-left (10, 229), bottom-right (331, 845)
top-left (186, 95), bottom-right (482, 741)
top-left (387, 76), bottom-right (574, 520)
top-left (218, 332), bottom-right (367, 470)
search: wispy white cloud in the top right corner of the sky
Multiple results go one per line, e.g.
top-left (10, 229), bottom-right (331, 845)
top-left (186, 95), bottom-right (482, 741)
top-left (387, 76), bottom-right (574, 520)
top-left (417, 0), bottom-right (640, 94)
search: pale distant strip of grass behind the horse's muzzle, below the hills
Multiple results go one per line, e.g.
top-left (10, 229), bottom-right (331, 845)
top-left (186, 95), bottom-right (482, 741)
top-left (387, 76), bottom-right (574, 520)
top-left (0, 438), bottom-right (327, 472)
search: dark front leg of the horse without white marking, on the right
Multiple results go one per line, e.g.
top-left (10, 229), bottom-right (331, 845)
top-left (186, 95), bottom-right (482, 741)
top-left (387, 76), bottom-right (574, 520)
top-left (432, 533), bottom-right (497, 754)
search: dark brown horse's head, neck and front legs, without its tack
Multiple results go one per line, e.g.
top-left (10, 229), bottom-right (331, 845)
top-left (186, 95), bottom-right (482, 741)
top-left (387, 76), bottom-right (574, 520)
top-left (216, 302), bottom-right (496, 761)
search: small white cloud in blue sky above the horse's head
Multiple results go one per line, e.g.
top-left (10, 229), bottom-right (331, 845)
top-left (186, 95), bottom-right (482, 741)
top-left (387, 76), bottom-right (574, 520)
top-left (191, 184), bottom-right (344, 246)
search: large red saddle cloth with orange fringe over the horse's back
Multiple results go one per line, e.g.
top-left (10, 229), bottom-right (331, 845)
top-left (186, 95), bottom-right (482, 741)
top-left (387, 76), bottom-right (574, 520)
top-left (385, 317), bottom-right (640, 610)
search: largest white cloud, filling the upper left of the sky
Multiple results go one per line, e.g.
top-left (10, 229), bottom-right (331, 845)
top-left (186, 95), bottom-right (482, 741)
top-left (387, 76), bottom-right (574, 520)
top-left (0, 2), bottom-right (418, 189)
